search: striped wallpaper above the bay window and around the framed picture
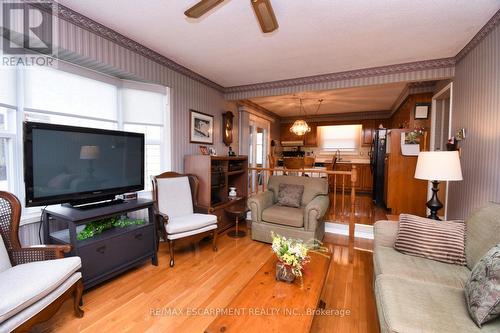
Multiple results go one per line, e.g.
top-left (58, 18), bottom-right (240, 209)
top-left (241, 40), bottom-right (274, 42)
top-left (58, 19), bottom-right (238, 172)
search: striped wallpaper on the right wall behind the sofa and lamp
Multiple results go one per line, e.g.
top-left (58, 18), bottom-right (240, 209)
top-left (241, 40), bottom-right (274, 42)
top-left (448, 25), bottom-right (500, 218)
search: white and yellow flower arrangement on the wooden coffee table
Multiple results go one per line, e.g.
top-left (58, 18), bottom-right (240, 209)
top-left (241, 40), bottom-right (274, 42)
top-left (271, 233), bottom-right (309, 276)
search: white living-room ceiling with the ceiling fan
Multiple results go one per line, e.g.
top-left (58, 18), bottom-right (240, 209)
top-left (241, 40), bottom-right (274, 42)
top-left (57, 0), bottom-right (500, 87)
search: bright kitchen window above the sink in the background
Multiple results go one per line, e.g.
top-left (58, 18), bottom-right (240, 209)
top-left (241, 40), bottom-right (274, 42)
top-left (318, 125), bottom-right (361, 152)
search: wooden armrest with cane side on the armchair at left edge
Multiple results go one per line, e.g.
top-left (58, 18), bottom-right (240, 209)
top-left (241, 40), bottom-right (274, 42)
top-left (12, 244), bottom-right (71, 265)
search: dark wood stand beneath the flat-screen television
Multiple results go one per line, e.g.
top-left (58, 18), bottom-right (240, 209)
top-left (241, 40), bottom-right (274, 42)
top-left (42, 199), bottom-right (158, 289)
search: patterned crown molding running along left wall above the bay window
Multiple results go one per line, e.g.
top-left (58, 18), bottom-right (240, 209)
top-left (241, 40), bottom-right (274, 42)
top-left (37, 0), bottom-right (224, 93)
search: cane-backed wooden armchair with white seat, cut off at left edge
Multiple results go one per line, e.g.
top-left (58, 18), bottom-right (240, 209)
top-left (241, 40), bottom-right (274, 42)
top-left (0, 191), bottom-right (83, 332)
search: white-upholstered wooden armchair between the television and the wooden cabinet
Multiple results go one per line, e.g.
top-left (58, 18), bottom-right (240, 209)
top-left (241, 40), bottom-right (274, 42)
top-left (153, 172), bottom-right (218, 267)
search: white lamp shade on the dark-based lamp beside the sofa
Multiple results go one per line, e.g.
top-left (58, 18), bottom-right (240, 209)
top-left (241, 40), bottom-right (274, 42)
top-left (415, 150), bottom-right (463, 181)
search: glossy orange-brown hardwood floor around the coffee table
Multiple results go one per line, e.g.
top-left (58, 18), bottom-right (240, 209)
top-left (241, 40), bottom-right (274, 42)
top-left (34, 196), bottom-right (386, 333)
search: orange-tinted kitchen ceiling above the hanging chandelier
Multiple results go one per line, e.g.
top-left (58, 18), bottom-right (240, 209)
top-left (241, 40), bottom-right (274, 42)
top-left (250, 83), bottom-right (406, 117)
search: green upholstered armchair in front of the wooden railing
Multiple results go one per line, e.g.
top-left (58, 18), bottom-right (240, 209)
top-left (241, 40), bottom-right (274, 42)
top-left (247, 175), bottom-right (330, 243)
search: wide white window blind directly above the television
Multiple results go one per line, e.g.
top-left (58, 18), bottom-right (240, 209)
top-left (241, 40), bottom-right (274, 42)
top-left (24, 67), bottom-right (118, 121)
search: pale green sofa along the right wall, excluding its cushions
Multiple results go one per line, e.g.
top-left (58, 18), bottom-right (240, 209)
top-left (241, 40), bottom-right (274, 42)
top-left (373, 203), bottom-right (500, 333)
